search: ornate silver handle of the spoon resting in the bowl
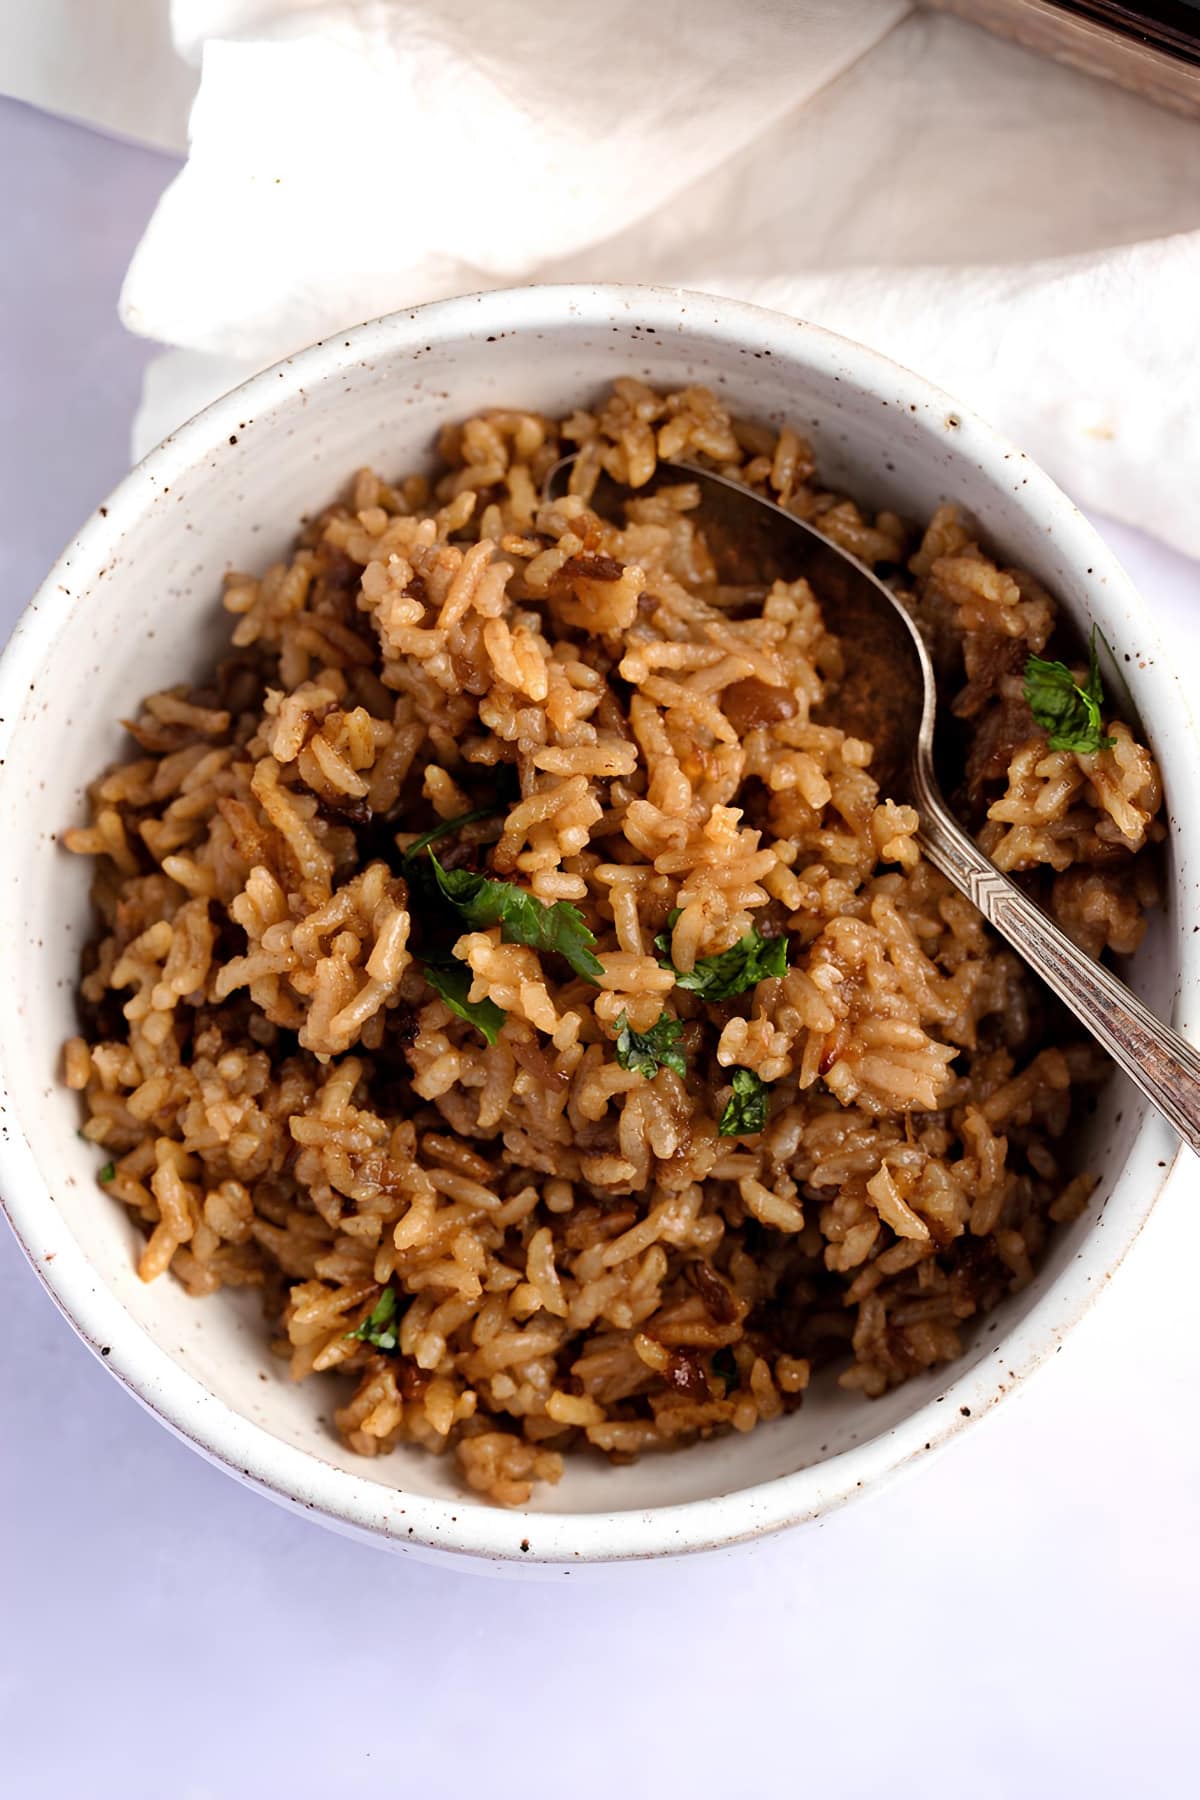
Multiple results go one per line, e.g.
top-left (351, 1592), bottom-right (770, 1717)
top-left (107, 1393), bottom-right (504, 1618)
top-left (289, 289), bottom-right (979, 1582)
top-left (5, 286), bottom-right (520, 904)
top-left (916, 774), bottom-right (1200, 1154)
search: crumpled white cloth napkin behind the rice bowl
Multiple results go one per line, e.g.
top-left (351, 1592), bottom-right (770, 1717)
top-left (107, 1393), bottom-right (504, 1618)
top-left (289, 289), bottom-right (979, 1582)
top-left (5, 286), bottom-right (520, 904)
top-left (9, 0), bottom-right (1200, 553)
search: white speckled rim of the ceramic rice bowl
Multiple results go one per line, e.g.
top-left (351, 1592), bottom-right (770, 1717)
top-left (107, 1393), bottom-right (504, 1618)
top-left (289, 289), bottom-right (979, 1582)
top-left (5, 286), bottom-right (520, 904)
top-left (0, 284), bottom-right (1200, 1566)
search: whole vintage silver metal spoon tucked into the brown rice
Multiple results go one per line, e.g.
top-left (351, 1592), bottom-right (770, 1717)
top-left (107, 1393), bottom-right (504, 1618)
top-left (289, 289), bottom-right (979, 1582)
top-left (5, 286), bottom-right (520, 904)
top-left (545, 457), bottom-right (1200, 1154)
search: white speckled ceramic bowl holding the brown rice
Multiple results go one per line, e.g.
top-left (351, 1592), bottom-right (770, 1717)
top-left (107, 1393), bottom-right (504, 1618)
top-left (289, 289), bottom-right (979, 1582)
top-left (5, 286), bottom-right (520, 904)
top-left (0, 286), bottom-right (1200, 1566)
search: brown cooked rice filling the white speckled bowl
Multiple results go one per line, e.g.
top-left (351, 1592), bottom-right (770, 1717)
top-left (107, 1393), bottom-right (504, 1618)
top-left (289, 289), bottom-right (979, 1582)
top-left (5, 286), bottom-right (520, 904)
top-left (65, 380), bottom-right (1162, 1505)
